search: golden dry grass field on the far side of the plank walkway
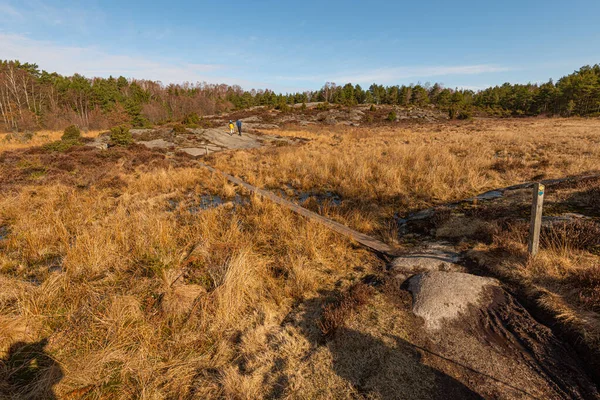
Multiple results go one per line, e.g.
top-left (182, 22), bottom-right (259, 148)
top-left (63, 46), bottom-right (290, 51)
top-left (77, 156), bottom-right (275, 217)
top-left (213, 119), bottom-right (600, 237)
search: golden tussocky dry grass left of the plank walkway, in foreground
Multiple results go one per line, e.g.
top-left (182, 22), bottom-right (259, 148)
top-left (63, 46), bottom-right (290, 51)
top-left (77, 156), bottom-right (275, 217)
top-left (0, 169), bottom-right (370, 398)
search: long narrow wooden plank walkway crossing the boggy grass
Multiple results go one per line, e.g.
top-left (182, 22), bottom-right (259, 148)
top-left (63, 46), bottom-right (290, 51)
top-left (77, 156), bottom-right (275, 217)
top-left (200, 163), bottom-right (395, 255)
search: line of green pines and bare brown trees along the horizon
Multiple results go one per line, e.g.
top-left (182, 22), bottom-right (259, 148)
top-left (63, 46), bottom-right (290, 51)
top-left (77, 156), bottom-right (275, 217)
top-left (0, 60), bottom-right (600, 131)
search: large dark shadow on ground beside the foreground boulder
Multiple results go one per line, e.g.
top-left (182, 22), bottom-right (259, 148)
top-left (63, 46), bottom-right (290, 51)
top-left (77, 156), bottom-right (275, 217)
top-left (290, 293), bottom-right (482, 399)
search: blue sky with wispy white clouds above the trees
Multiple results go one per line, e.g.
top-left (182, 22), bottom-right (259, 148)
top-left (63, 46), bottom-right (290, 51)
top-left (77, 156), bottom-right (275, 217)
top-left (0, 0), bottom-right (600, 92)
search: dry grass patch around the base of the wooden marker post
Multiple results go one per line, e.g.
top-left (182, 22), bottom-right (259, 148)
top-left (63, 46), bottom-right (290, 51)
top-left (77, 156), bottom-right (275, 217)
top-left (473, 221), bottom-right (600, 328)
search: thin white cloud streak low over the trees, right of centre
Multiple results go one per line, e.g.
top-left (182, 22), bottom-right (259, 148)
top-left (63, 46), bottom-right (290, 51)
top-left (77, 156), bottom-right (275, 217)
top-left (276, 64), bottom-right (512, 83)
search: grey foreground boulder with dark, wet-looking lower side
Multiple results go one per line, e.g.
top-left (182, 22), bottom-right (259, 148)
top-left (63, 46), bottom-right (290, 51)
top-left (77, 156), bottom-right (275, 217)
top-left (407, 271), bottom-right (599, 399)
